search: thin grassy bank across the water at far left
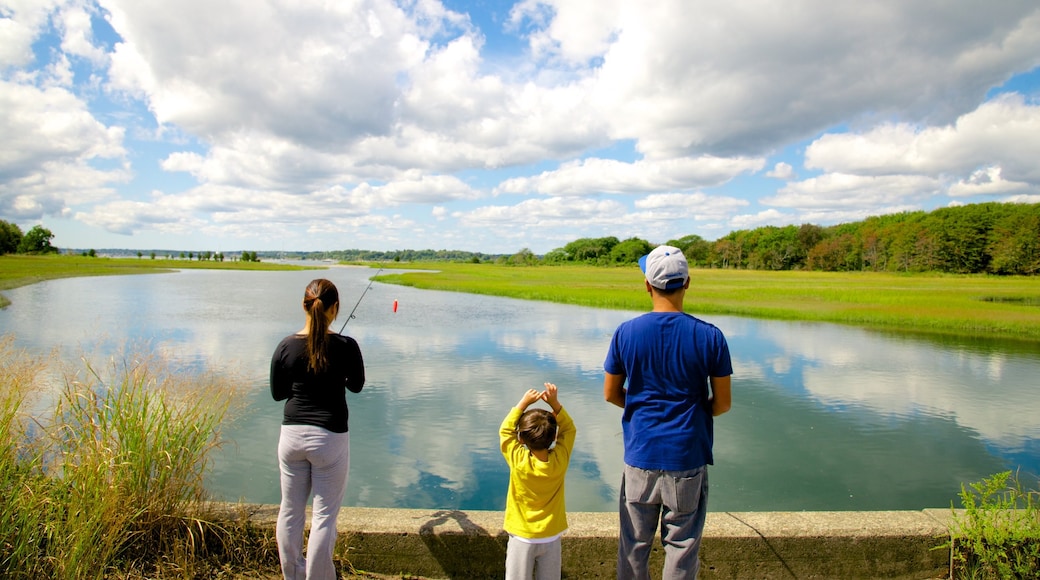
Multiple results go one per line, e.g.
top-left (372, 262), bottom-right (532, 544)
top-left (0, 254), bottom-right (323, 308)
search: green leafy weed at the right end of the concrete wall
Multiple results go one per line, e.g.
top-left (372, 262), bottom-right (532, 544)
top-left (946, 471), bottom-right (1040, 580)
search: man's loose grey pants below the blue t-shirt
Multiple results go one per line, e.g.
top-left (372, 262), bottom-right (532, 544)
top-left (618, 465), bottom-right (708, 580)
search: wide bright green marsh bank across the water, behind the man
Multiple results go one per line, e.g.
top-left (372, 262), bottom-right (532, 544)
top-left (376, 264), bottom-right (1040, 341)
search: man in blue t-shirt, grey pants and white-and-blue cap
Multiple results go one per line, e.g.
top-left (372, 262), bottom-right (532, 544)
top-left (603, 245), bottom-right (733, 580)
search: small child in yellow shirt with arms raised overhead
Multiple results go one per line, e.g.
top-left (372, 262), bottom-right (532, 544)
top-left (498, 383), bottom-right (576, 580)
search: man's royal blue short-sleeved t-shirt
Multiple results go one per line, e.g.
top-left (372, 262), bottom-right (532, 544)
top-left (603, 312), bottom-right (733, 471)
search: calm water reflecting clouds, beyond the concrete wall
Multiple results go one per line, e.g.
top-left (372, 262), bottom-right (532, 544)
top-left (0, 267), bottom-right (1040, 511)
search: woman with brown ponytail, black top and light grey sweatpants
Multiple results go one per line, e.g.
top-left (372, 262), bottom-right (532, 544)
top-left (270, 279), bottom-right (365, 580)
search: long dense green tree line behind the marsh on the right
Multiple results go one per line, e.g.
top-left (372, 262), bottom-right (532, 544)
top-left (542, 203), bottom-right (1040, 274)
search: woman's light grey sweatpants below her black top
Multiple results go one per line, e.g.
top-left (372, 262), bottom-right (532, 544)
top-left (275, 425), bottom-right (350, 580)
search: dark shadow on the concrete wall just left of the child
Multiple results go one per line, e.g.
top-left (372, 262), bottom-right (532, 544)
top-left (419, 510), bottom-right (509, 578)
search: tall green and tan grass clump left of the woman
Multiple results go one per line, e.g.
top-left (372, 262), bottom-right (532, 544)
top-left (0, 337), bottom-right (278, 580)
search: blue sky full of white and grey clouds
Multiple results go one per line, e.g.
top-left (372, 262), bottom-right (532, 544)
top-left (0, 0), bottom-right (1040, 254)
